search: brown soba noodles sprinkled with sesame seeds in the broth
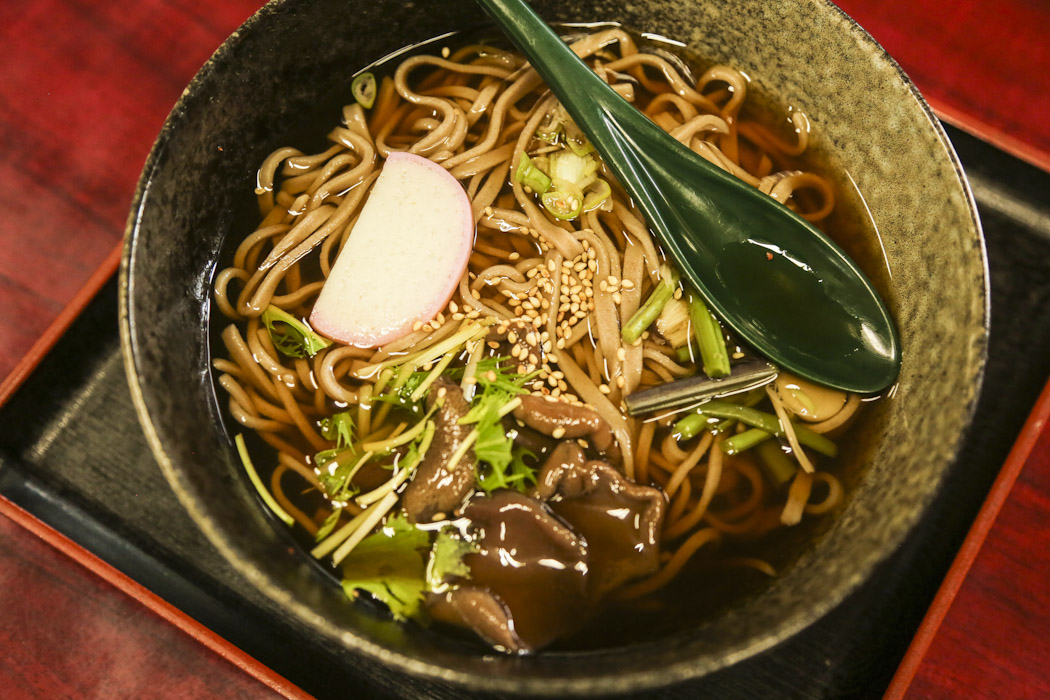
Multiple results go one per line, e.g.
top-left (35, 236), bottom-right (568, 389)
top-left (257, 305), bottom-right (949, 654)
top-left (208, 28), bottom-right (859, 646)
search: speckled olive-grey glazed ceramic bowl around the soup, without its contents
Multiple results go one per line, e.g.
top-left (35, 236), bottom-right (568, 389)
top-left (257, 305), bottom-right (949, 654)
top-left (121, 0), bottom-right (988, 695)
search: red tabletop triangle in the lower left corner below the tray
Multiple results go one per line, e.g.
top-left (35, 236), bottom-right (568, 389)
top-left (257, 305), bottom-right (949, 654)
top-left (0, 497), bottom-right (310, 700)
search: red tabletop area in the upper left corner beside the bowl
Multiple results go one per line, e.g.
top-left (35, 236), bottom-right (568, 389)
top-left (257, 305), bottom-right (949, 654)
top-left (0, 0), bottom-right (261, 400)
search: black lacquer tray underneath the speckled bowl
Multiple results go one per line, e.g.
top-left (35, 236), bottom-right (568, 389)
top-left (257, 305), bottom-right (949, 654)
top-left (0, 127), bottom-right (1050, 700)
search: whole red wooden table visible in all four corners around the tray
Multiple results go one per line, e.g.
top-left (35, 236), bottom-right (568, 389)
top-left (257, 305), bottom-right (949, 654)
top-left (0, 0), bottom-right (1050, 698)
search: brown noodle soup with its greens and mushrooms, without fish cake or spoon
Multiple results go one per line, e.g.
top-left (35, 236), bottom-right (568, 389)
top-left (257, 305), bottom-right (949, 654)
top-left (212, 25), bottom-right (893, 653)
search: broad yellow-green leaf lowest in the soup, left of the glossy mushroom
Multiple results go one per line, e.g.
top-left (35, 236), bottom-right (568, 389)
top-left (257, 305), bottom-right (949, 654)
top-left (342, 515), bottom-right (431, 619)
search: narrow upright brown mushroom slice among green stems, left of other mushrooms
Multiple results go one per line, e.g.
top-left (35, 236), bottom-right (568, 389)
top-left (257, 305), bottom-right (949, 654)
top-left (401, 378), bottom-right (475, 523)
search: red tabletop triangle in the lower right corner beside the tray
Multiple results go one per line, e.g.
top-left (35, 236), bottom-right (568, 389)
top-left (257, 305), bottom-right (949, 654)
top-left (886, 383), bottom-right (1050, 700)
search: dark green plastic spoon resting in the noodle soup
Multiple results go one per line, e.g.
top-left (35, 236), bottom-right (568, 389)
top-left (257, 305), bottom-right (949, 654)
top-left (478, 0), bottom-right (901, 394)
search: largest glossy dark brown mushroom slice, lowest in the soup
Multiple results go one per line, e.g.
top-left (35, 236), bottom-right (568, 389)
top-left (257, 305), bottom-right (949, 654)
top-left (442, 490), bottom-right (591, 652)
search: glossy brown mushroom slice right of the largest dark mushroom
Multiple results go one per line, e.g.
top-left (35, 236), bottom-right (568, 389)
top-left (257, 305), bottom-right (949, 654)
top-left (537, 449), bottom-right (666, 597)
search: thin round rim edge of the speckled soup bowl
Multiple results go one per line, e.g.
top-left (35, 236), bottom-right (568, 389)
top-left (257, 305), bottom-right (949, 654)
top-left (118, 0), bottom-right (990, 696)
